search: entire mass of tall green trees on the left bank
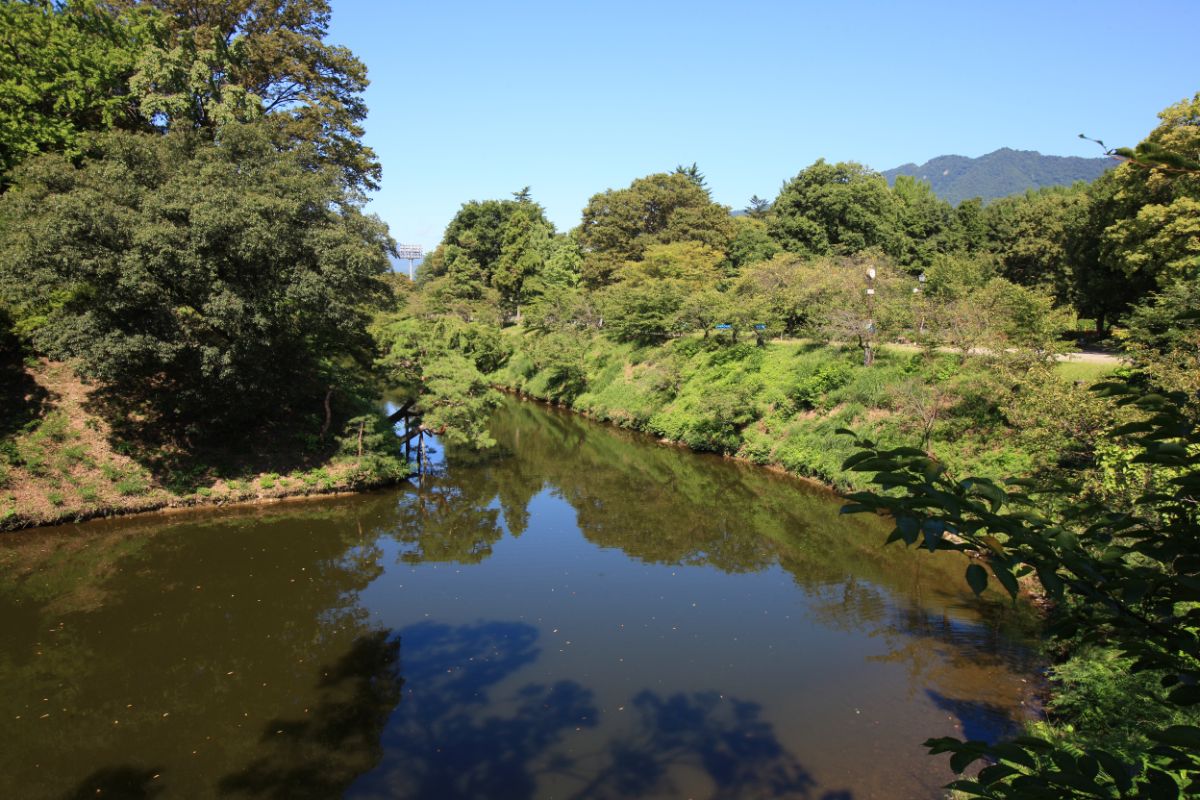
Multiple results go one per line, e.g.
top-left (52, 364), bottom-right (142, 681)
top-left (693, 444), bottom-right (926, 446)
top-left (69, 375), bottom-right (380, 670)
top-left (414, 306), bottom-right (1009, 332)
top-left (0, 0), bottom-right (397, 485)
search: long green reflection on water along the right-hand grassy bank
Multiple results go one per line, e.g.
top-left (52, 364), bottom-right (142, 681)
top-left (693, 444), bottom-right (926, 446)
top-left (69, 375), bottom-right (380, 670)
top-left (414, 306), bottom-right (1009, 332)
top-left (393, 402), bottom-right (1036, 753)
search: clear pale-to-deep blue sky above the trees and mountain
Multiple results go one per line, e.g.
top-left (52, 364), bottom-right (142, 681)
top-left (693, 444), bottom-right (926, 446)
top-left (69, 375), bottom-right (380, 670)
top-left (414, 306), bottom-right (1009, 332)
top-left (329, 0), bottom-right (1200, 249)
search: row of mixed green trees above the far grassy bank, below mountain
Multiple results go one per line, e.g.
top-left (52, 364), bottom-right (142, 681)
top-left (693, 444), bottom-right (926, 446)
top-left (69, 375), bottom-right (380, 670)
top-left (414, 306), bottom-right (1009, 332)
top-left (419, 90), bottom-right (1200, 362)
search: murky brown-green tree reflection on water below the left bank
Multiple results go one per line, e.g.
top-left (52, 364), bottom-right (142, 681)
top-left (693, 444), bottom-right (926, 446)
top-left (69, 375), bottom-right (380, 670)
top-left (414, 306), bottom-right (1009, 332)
top-left (0, 498), bottom-right (395, 798)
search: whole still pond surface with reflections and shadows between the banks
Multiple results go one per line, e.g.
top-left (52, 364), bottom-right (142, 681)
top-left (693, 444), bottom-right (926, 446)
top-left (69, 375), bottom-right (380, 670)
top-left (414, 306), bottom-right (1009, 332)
top-left (0, 402), bottom-right (1033, 800)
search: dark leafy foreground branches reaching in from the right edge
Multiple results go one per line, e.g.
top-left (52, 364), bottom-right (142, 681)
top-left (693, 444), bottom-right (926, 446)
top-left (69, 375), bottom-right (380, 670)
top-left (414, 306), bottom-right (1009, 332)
top-left (844, 379), bottom-right (1200, 800)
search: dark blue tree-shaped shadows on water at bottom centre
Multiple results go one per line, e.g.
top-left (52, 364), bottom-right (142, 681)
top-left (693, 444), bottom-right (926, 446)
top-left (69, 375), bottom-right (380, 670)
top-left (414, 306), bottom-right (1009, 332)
top-left (349, 621), bottom-right (850, 800)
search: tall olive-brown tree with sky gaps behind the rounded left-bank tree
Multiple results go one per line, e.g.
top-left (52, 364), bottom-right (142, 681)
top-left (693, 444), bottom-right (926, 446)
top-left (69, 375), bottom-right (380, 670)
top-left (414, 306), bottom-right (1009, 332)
top-left (112, 0), bottom-right (380, 188)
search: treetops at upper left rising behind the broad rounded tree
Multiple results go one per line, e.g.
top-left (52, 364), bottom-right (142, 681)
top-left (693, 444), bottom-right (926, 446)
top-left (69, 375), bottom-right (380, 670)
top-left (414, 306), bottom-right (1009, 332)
top-left (0, 0), bottom-right (379, 188)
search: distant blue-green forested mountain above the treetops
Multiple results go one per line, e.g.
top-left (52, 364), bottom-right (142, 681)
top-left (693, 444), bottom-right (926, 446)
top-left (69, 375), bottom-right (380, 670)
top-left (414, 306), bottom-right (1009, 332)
top-left (883, 148), bottom-right (1116, 205)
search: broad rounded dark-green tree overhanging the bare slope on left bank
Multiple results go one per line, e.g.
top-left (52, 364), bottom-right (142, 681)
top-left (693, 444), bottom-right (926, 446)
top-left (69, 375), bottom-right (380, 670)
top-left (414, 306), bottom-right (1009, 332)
top-left (0, 124), bottom-right (391, 437)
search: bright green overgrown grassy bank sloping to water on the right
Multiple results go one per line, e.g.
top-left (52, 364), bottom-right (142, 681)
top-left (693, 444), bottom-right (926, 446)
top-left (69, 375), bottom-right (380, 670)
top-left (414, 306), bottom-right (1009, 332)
top-left (492, 329), bottom-right (1113, 489)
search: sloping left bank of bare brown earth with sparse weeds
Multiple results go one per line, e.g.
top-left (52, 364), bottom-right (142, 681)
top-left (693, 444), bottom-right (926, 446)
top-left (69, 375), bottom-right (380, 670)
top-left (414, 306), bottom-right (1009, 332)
top-left (0, 361), bottom-right (408, 531)
